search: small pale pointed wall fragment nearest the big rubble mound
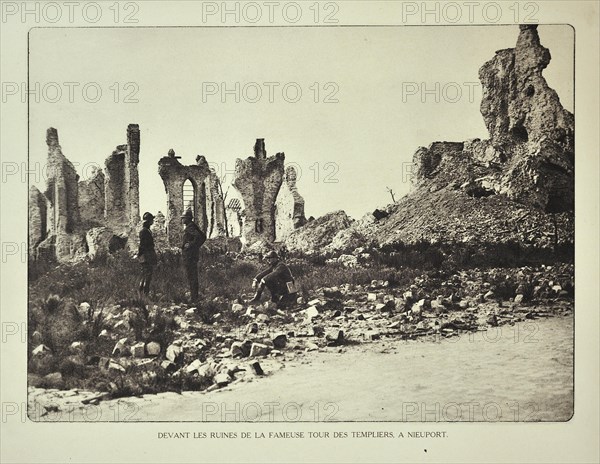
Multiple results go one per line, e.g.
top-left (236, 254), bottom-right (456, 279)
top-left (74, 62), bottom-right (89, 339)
top-left (275, 166), bottom-right (306, 241)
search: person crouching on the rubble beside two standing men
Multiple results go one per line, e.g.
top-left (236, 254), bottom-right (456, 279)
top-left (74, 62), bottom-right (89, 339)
top-left (249, 251), bottom-right (297, 307)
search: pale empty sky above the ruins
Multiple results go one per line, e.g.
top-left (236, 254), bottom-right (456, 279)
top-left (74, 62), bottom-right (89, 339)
top-left (30, 26), bottom-right (573, 218)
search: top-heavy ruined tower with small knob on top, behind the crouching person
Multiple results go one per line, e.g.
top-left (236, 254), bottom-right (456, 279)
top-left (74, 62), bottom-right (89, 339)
top-left (233, 139), bottom-right (285, 246)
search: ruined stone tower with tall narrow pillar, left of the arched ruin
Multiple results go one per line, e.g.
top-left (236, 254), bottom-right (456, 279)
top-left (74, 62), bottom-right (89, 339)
top-left (104, 124), bottom-right (140, 232)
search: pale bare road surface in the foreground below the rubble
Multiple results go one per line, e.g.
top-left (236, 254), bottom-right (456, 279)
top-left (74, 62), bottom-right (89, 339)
top-left (30, 315), bottom-right (573, 422)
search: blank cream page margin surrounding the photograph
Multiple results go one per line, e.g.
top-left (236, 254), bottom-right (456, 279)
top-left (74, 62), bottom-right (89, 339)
top-left (0, 1), bottom-right (600, 463)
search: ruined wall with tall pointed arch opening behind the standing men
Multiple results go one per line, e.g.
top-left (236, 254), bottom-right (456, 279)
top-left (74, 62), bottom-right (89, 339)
top-left (158, 149), bottom-right (210, 246)
